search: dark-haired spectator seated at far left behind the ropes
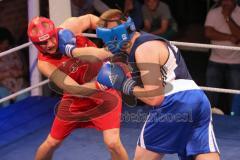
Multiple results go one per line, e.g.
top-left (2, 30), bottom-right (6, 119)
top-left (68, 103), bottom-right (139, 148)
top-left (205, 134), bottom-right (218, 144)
top-left (0, 27), bottom-right (26, 106)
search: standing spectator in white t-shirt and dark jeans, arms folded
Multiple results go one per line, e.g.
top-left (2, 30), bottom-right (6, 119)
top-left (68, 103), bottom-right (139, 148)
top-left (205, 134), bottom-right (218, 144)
top-left (205, 0), bottom-right (240, 114)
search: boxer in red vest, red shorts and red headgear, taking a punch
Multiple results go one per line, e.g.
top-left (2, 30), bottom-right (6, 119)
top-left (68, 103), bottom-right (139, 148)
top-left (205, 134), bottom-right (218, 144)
top-left (28, 15), bottom-right (128, 160)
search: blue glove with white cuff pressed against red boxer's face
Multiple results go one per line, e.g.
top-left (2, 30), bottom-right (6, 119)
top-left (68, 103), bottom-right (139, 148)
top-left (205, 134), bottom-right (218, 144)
top-left (58, 29), bottom-right (76, 57)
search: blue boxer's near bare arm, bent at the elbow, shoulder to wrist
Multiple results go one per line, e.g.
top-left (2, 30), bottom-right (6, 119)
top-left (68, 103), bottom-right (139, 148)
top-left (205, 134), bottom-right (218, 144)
top-left (133, 42), bottom-right (164, 106)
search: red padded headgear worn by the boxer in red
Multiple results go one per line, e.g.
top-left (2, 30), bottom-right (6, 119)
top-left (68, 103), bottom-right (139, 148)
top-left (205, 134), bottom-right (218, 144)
top-left (28, 17), bottom-right (58, 53)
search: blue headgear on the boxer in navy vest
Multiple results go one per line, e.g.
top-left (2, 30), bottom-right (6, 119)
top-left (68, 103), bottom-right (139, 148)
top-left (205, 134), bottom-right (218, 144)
top-left (96, 17), bottom-right (136, 54)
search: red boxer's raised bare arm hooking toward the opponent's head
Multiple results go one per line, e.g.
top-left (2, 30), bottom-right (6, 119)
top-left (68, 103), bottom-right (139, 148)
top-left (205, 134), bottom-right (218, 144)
top-left (59, 14), bottom-right (99, 35)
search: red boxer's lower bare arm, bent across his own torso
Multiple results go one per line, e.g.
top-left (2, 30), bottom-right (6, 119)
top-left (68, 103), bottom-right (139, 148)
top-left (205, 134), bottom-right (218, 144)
top-left (38, 60), bottom-right (97, 96)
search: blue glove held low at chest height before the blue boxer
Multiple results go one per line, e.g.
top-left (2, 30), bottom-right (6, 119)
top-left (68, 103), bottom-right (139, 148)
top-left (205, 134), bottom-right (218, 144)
top-left (97, 62), bottom-right (136, 95)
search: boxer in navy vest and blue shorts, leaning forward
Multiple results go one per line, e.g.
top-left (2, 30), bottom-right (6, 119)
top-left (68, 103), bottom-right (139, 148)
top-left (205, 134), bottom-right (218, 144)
top-left (96, 10), bottom-right (220, 160)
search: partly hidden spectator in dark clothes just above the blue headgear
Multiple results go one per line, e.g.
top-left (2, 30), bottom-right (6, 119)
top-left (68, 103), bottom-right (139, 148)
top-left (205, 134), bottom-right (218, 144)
top-left (124, 0), bottom-right (143, 29)
